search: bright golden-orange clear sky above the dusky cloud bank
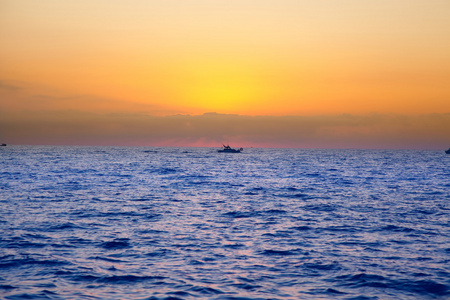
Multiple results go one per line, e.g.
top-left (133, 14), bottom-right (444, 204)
top-left (0, 0), bottom-right (450, 147)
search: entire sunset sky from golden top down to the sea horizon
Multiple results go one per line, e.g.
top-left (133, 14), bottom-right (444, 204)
top-left (0, 0), bottom-right (450, 149)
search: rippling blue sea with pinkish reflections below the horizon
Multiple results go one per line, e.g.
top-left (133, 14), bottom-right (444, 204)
top-left (0, 146), bottom-right (450, 300)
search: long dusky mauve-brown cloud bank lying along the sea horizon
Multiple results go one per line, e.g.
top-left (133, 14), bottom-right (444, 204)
top-left (0, 110), bottom-right (450, 149)
